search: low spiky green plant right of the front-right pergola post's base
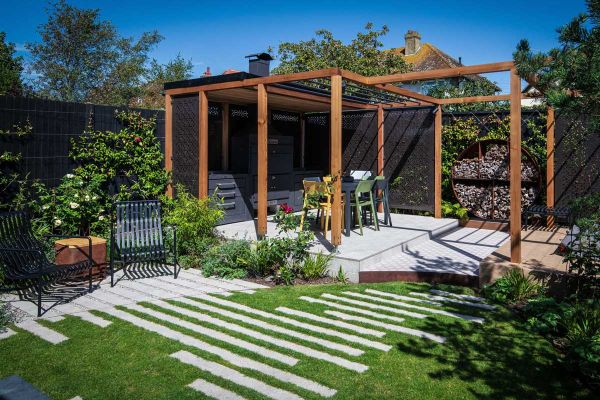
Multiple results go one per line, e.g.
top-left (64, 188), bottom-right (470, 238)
top-left (483, 268), bottom-right (543, 304)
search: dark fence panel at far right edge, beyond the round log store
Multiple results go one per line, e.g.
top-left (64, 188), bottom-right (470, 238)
top-left (554, 113), bottom-right (600, 207)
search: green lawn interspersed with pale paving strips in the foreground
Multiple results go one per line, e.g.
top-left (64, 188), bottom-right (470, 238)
top-left (0, 283), bottom-right (591, 400)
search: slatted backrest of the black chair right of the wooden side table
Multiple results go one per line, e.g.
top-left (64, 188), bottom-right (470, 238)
top-left (114, 200), bottom-right (166, 261)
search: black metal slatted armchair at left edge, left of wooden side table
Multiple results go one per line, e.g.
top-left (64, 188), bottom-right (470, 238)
top-left (0, 212), bottom-right (94, 317)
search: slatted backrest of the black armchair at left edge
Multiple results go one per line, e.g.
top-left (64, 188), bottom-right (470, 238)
top-left (0, 211), bottom-right (48, 279)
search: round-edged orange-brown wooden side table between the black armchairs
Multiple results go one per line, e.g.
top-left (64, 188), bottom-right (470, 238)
top-left (54, 236), bottom-right (107, 279)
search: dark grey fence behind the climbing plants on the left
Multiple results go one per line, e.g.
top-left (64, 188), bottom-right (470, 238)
top-left (0, 96), bottom-right (165, 186)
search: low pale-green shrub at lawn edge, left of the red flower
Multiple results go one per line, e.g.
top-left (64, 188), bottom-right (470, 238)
top-left (202, 240), bottom-right (252, 279)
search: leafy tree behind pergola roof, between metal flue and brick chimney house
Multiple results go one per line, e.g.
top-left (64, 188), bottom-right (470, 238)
top-left (273, 23), bottom-right (409, 76)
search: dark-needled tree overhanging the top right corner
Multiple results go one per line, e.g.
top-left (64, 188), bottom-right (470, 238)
top-left (513, 0), bottom-right (600, 128)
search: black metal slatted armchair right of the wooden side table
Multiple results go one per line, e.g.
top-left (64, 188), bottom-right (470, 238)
top-left (110, 200), bottom-right (179, 286)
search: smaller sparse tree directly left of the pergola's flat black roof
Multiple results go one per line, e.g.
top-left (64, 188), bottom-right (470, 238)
top-left (135, 54), bottom-right (193, 108)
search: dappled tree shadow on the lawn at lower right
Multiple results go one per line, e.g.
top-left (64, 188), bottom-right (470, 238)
top-left (397, 311), bottom-right (592, 399)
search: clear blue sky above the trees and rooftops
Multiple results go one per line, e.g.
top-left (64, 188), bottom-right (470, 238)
top-left (0, 0), bottom-right (585, 92)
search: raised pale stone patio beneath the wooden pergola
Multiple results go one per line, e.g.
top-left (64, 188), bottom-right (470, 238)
top-left (219, 214), bottom-right (508, 285)
